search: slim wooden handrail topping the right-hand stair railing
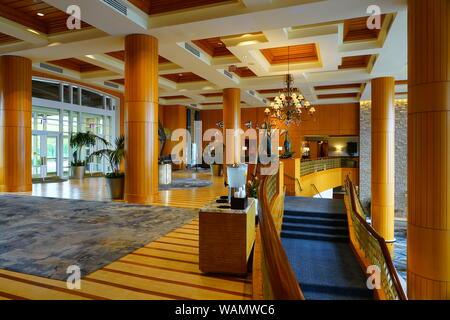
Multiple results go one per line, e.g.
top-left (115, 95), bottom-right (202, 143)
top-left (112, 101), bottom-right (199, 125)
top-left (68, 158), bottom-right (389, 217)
top-left (346, 177), bottom-right (408, 300)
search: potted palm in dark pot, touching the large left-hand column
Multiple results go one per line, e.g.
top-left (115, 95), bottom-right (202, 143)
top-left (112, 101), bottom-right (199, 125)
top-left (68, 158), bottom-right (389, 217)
top-left (88, 136), bottom-right (125, 200)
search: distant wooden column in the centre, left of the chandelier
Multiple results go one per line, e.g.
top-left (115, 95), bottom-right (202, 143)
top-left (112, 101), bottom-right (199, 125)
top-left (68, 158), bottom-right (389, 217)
top-left (223, 88), bottom-right (241, 164)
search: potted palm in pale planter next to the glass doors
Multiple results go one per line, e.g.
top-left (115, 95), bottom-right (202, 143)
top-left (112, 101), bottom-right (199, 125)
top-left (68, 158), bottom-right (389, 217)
top-left (69, 131), bottom-right (108, 179)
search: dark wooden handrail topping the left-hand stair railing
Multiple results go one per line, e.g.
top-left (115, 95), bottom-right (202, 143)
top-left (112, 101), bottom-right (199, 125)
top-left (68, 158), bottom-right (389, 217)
top-left (254, 172), bottom-right (305, 300)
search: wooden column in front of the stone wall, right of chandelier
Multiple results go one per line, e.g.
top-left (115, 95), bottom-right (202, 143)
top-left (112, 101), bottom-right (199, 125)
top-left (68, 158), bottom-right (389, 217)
top-left (372, 77), bottom-right (395, 255)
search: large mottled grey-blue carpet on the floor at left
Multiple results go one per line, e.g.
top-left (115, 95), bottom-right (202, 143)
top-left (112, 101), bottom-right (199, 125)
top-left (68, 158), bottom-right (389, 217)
top-left (0, 195), bottom-right (197, 280)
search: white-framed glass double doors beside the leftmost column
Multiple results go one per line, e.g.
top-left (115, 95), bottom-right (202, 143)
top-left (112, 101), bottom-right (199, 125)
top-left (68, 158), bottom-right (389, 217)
top-left (32, 133), bottom-right (60, 179)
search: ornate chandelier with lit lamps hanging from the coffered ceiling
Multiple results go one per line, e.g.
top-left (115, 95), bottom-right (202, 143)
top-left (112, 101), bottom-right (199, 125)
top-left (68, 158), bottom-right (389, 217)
top-left (265, 47), bottom-right (316, 125)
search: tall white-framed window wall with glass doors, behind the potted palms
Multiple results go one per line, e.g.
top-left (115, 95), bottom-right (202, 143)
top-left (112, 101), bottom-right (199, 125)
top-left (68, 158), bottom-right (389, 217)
top-left (31, 79), bottom-right (120, 178)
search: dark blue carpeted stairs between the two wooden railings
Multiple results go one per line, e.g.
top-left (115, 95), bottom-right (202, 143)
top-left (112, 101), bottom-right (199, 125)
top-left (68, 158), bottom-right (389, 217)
top-left (281, 197), bottom-right (373, 300)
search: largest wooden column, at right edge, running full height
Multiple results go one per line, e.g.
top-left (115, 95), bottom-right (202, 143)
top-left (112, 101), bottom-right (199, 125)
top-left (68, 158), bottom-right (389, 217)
top-left (408, 0), bottom-right (450, 299)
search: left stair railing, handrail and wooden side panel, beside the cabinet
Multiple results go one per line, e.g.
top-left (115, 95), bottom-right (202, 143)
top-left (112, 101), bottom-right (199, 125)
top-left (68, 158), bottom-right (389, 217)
top-left (253, 173), bottom-right (305, 300)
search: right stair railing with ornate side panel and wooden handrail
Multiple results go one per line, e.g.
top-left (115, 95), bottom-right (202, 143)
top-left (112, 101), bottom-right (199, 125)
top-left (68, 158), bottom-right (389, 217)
top-left (345, 177), bottom-right (408, 300)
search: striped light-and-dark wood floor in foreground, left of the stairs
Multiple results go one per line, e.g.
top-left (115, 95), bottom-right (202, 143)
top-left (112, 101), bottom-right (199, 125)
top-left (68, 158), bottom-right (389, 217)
top-left (0, 219), bottom-right (252, 300)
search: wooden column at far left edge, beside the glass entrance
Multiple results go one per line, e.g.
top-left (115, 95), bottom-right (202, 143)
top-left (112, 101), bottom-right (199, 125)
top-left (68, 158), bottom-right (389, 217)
top-left (0, 56), bottom-right (32, 192)
